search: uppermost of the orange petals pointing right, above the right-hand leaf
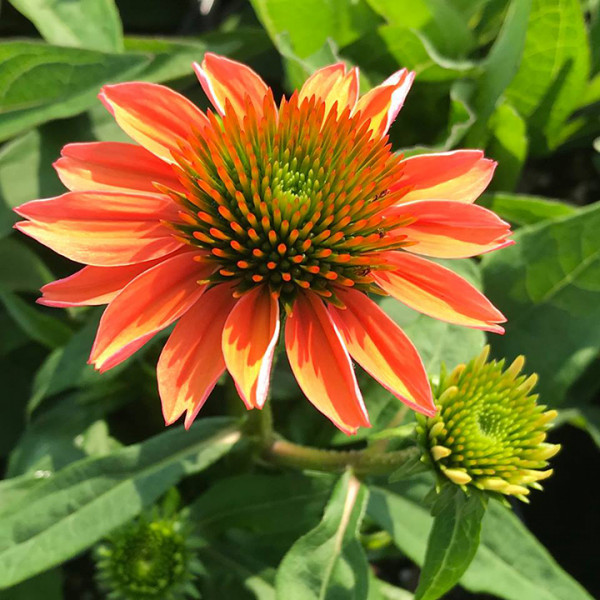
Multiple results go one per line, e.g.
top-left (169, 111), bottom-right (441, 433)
top-left (390, 150), bottom-right (496, 202)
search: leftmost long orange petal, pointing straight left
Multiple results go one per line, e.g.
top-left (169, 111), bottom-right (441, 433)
top-left (15, 192), bottom-right (182, 267)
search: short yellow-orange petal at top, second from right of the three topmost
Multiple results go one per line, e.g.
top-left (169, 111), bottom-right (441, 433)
top-left (298, 63), bottom-right (359, 115)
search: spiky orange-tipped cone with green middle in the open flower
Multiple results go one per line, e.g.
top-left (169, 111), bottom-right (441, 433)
top-left (170, 92), bottom-right (407, 308)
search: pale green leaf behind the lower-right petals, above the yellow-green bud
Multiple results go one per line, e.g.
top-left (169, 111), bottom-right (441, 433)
top-left (379, 259), bottom-right (485, 378)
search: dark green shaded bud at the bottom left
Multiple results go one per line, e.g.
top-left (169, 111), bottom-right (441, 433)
top-left (96, 519), bottom-right (199, 600)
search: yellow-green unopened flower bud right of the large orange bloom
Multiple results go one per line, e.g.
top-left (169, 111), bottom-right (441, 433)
top-left (418, 348), bottom-right (560, 501)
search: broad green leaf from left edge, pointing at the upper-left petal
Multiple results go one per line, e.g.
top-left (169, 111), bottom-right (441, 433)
top-left (0, 42), bottom-right (150, 141)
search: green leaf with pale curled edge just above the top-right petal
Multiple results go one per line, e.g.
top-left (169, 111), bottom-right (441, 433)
top-left (341, 25), bottom-right (476, 82)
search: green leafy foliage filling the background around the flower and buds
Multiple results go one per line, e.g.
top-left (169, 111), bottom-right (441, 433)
top-left (0, 0), bottom-right (600, 600)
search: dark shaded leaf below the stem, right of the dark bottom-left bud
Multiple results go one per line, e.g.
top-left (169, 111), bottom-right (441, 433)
top-left (189, 473), bottom-right (332, 535)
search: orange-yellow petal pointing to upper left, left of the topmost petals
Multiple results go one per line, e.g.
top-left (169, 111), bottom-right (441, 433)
top-left (99, 82), bottom-right (208, 163)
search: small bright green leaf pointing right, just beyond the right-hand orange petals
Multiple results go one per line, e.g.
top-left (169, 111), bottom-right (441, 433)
top-left (479, 193), bottom-right (577, 225)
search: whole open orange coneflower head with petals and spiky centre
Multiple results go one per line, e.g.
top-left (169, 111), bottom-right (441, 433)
top-left (17, 54), bottom-right (511, 433)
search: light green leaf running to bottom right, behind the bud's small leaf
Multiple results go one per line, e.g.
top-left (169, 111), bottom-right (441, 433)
top-left (367, 476), bottom-right (592, 600)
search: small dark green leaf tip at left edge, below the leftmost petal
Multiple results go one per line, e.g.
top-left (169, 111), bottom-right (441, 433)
top-left (0, 236), bottom-right (53, 293)
